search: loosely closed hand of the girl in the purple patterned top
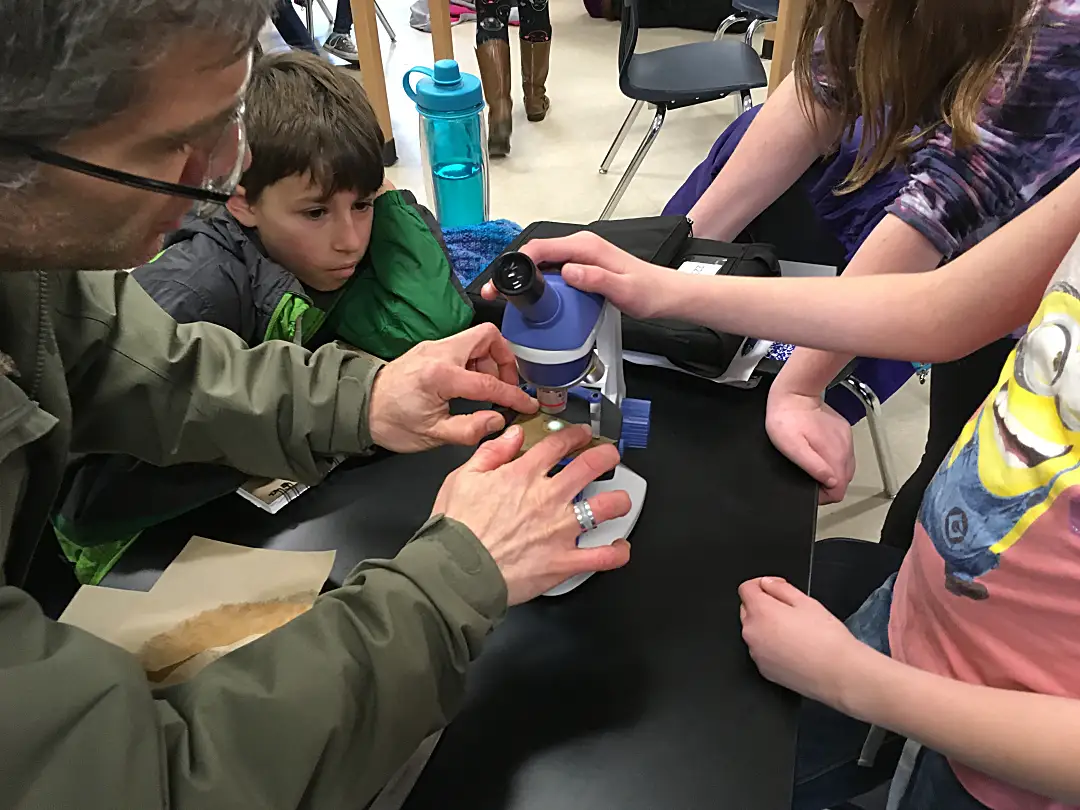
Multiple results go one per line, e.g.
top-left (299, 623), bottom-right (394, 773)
top-left (765, 383), bottom-right (855, 503)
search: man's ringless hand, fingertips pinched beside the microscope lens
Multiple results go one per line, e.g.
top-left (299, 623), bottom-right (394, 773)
top-left (368, 324), bottom-right (537, 453)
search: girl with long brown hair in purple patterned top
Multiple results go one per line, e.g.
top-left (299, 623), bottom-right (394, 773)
top-left (665, 0), bottom-right (1080, 561)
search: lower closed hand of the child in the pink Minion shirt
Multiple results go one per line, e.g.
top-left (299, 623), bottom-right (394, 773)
top-left (739, 577), bottom-right (879, 710)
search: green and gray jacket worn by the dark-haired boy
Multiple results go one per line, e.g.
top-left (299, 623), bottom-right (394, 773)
top-left (53, 191), bottom-right (472, 584)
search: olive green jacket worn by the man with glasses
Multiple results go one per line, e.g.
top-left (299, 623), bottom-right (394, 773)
top-left (0, 271), bottom-right (507, 810)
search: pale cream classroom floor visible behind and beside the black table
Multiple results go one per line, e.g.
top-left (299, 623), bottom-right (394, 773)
top-left (267, 0), bottom-right (928, 539)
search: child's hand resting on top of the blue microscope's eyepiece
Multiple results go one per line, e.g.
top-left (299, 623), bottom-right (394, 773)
top-left (481, 231), bottom-right (679, 318)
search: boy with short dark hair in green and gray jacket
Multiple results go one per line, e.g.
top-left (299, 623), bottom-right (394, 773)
top-left (53, 51), bottom-right (472, 582)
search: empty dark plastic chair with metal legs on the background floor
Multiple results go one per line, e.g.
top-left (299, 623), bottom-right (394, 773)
top-left (599, 0), bottom-right (768, 219)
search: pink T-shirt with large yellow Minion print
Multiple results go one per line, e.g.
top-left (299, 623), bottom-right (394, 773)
top-left (887, 276), bottom-right (1080, 810)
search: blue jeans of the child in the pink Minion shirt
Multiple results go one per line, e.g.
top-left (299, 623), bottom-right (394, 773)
top-left (793, 557), bottom-right (986, 810)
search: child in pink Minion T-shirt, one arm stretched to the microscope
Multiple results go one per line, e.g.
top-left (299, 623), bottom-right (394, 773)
top-left (524, 173), bottom-right (1080, 810)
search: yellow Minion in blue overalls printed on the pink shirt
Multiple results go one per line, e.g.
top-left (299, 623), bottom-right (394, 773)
top-left (919, 281), bottom-right (1080, 599)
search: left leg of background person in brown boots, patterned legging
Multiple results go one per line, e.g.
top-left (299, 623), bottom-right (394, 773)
top-left (476, 0), bottom-right (514, 158)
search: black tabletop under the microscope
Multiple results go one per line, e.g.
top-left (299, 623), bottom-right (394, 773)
top-left (111, 366), bottom-right (816, 810)
